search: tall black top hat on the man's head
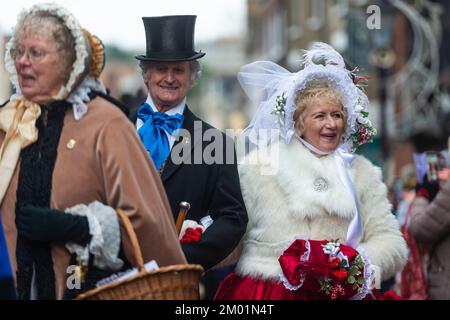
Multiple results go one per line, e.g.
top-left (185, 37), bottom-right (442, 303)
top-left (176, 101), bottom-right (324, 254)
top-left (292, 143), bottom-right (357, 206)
top-left (135, 16), bottom-right (205, 61)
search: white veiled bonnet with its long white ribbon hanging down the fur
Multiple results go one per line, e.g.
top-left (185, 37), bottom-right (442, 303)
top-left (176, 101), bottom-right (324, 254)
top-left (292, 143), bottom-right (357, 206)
top-left (238, 42), bottom-right (376, 247)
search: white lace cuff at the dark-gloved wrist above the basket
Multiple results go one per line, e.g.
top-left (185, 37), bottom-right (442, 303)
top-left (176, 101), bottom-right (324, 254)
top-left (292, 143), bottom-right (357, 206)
top-left (65, 201), bottom-right (123, 270)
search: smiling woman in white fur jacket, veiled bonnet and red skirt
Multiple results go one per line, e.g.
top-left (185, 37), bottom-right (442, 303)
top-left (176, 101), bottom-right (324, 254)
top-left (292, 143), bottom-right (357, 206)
top-left (215, 43), bottom-right (407, 299)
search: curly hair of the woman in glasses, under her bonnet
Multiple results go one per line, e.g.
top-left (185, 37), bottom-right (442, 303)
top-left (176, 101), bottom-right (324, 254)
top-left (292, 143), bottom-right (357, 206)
top-left (15, 11), bottom-right (76, 81)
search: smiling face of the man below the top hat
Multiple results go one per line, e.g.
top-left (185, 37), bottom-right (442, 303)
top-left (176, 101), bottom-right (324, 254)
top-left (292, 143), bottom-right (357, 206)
top-left (144, 61), bottom-right (192, 112)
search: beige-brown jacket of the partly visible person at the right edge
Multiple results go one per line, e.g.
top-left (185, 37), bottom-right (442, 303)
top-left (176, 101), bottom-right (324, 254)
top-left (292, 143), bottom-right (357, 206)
top-left (409, 180), bottom-right (450, 300)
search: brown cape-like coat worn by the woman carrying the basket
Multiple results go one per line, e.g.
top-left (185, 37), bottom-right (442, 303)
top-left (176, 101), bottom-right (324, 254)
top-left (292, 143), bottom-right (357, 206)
top-left (0, 97), bottom-right (186, 298)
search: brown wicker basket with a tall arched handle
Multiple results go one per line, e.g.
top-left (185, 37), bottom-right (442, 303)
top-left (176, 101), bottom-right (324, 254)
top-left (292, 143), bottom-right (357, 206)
top-left (75, 209), bottom-right (203, 300)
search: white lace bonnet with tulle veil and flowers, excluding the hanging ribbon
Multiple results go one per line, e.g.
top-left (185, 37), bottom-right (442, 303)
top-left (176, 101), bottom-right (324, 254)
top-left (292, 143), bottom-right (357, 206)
top-left (238, 42), bottom-right (376, 152)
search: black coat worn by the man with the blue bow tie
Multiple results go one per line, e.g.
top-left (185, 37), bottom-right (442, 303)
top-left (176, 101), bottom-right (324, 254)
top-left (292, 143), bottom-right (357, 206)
top-left (135, 106), bottom-right (248, 270)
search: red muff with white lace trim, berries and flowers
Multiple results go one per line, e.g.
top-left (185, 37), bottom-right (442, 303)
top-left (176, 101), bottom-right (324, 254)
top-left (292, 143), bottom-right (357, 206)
top-left (278, 239), bottom-right (372, 300)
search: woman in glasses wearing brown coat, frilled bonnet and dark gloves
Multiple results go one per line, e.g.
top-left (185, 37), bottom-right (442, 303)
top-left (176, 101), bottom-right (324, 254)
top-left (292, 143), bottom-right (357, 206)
top-left (0, 4), bottom-right (186, 299)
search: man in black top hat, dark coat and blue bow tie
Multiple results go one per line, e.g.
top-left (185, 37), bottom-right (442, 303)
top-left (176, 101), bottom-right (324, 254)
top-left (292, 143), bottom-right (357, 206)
top-left (132, 15), bottom-right (247, 276)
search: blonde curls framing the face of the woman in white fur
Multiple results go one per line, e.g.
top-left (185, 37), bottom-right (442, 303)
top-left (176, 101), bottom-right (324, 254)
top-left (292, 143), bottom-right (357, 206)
top-left (293, 81), bottom-right (347, 134)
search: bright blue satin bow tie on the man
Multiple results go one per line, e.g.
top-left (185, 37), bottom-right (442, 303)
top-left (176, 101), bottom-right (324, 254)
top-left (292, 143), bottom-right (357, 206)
top-left (137, 103), bottom-right (184, 169)
